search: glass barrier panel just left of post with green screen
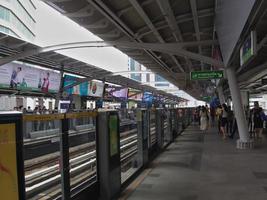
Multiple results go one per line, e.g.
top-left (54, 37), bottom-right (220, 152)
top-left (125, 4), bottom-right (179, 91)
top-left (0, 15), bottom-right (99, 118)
top-left (69, 113), bottom-right (97, 195)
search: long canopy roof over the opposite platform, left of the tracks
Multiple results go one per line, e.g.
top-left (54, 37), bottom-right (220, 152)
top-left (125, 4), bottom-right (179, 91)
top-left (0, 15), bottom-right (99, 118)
top-left (0, 33), bottom-right (185, 102)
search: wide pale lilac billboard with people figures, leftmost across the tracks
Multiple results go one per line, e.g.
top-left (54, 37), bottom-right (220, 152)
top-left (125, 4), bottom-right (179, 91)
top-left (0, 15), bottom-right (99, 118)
top-left (0, 63), bottom-right (60, 93)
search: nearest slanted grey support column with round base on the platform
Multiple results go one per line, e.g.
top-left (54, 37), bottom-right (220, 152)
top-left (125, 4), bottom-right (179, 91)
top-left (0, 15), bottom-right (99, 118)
top-left (226, 67), bottom-right (253, 149)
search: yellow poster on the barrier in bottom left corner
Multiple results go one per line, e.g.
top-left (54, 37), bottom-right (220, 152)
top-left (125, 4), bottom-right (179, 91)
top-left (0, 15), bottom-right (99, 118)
top-left (0, 124), bottom-right (19, 200)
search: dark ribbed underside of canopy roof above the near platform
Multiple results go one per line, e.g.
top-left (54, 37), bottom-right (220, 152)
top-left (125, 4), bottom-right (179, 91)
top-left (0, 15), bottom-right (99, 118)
top-left (43, 0), bottom-right (221, 98)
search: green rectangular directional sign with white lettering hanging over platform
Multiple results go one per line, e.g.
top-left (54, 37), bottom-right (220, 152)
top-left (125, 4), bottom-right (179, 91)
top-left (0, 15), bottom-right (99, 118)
top-left (190, 71), bottom-right (223, 80)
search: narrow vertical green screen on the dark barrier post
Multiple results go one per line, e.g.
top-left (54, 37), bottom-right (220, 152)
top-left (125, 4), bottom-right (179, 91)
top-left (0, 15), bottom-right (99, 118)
top-left (109, 115), bottom-right (118, 157)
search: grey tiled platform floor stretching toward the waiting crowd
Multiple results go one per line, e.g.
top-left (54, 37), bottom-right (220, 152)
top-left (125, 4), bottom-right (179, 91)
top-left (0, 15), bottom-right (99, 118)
top-left (120, 125), bottom-right (267, 200)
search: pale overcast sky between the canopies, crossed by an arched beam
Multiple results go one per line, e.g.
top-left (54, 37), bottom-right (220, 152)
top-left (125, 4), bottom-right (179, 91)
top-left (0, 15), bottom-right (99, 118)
top-left (35, 0), bottom-right (128, 72)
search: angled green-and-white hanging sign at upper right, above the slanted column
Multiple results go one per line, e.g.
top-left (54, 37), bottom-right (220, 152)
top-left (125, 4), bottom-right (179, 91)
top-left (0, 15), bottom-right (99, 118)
top-left (240, 31), bottom-right (257, 66)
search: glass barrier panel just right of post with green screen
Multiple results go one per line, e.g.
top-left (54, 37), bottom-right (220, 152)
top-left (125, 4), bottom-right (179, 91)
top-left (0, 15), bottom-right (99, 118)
top-left (119, 109), bottom-right (142, 183)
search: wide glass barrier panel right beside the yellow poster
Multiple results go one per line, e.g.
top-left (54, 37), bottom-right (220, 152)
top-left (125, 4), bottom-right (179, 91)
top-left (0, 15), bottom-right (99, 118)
top-left (23, 115), bottom-right (61, 200)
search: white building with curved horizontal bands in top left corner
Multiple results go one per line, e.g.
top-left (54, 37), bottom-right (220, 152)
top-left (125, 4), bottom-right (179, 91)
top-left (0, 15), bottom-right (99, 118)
top-left (0, 0), bottom-right (36, 42)
